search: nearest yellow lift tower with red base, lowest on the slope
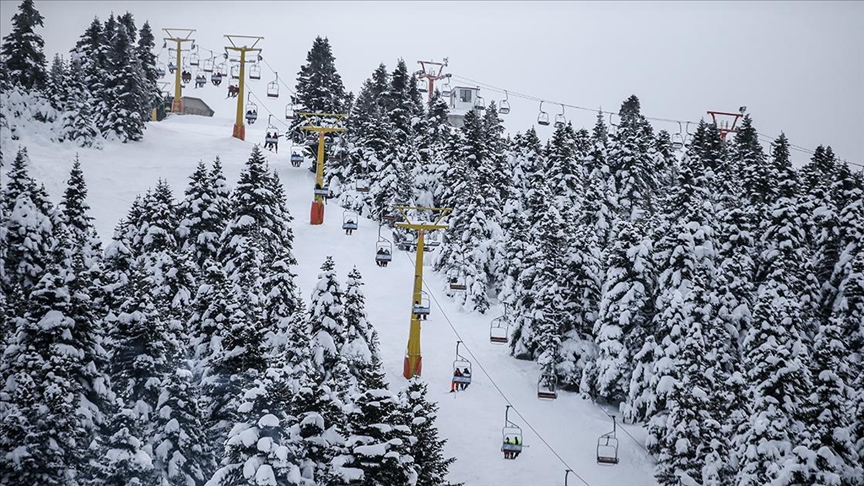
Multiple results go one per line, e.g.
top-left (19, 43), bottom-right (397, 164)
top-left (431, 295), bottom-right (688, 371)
top-left (395, 206), bottom-right (453, 380)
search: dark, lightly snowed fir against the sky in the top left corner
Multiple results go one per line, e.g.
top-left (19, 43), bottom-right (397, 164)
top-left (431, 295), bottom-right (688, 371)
top-left (0, 0), bottom-right (48, 91)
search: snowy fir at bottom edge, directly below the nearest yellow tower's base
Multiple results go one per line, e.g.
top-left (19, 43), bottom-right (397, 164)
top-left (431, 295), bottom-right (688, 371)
top-left (399, 377), bottom-right (460, 486)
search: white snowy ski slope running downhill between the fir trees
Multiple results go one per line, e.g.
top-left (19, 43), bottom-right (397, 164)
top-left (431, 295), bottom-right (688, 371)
top-left (2, 88), bottom-right (657, 486)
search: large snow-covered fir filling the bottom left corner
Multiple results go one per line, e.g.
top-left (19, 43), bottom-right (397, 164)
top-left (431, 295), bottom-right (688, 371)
top-left (0, 252), bottom-right (98, 485)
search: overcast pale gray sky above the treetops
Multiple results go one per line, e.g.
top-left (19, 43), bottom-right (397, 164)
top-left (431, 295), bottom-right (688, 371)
top-left (0, 0), bottom-right (864, 169)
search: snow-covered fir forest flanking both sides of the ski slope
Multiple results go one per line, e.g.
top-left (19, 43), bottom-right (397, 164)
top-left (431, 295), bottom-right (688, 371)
top-left (0, 0), bottom-right (864, 486)
